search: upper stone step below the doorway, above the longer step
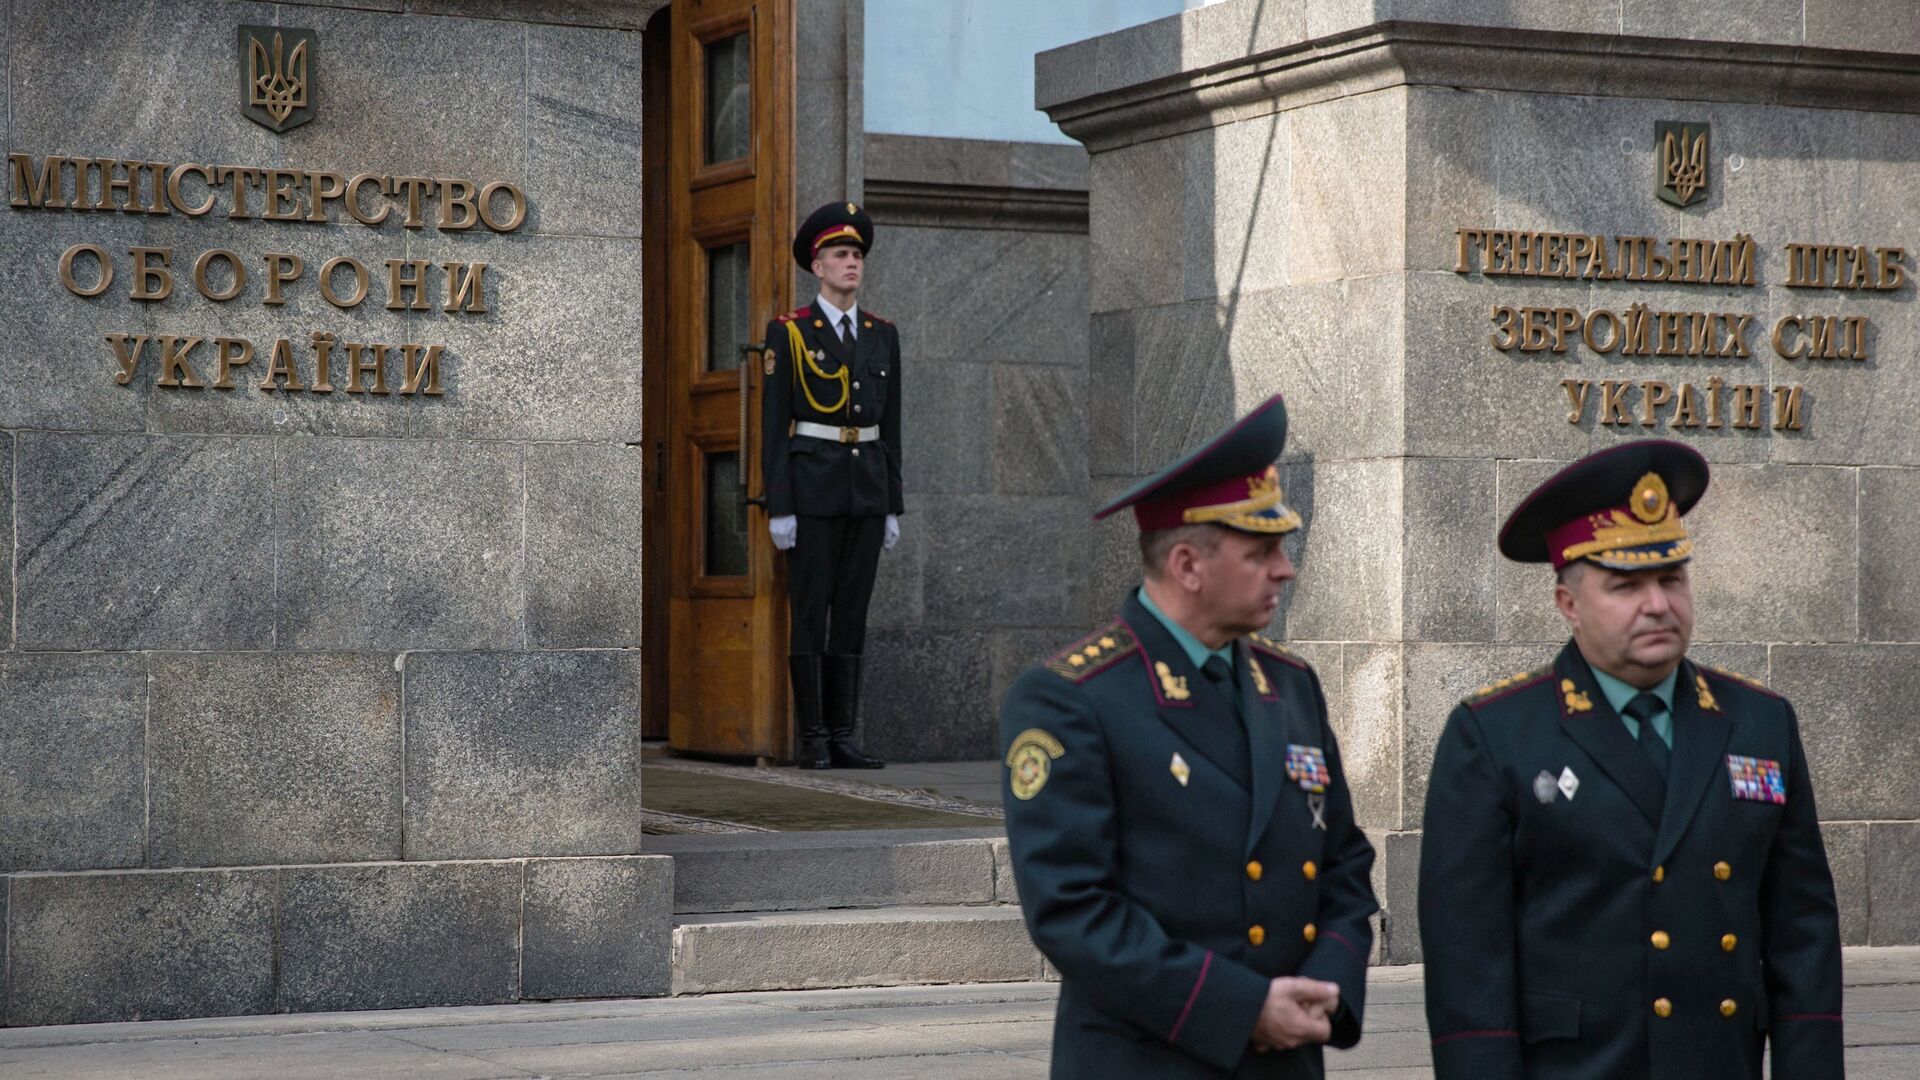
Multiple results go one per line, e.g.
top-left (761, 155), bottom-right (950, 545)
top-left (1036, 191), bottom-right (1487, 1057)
top-left (647, 826), bottom-right (1018, 915)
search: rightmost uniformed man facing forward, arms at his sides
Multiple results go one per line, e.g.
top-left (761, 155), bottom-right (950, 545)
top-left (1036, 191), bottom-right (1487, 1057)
top-left (1419, 440), bottom-right (1845, 1080)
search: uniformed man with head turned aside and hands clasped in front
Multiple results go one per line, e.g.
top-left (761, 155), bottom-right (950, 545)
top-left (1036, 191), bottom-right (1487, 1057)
top-left (1000, 396), bottom-right (1379, 1080)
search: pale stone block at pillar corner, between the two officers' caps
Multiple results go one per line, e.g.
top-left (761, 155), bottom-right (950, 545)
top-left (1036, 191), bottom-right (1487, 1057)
top-left (1402, 457), bottom-right (1500, 642)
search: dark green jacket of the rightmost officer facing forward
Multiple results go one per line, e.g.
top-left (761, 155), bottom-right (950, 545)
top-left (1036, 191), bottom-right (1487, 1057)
top-left (1419, 644), bottom-right (1845, 1080)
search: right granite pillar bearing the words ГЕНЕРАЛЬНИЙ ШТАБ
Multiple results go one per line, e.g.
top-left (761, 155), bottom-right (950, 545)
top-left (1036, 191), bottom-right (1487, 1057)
top-left (1037, 0), bottom-right (1920, 963)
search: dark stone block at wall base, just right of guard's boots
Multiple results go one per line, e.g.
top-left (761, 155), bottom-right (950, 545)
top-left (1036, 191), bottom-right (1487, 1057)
top-left (860, 630), bottom-right (998, 761)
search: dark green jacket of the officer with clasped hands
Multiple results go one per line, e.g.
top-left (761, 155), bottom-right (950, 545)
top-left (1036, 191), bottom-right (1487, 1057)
top-left (1000, 598), bottom-right (1377, 1080)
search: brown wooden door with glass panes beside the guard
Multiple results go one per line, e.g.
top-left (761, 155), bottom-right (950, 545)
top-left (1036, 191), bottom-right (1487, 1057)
top-left (649, 0), bottom-right (793, 759)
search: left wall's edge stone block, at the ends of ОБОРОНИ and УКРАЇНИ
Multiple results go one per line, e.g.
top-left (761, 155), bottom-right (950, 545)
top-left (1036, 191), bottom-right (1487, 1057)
top-left (407, 233), bottom-right (645, 442)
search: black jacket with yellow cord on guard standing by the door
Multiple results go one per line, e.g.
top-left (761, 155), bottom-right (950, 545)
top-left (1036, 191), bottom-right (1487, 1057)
top-left (760, 306), bottom-right (906, 517)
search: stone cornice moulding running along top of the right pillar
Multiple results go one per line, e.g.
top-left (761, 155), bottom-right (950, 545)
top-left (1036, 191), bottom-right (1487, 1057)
top-left (1043, 21), bottom-right (1920, 150)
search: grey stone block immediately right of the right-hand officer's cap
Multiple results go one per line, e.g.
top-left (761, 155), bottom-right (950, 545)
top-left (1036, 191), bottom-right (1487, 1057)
top-left (1688, 465), bottom-right (1859, 642)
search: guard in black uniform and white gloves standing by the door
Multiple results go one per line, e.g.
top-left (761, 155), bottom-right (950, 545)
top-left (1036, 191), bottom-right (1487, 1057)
top-left (760, 202), bottom-right (904, 769)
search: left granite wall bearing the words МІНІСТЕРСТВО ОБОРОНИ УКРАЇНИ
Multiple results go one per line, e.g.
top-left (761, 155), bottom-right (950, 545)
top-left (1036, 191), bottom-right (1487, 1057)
top-left (0, 0), bottom-right (672, 1024)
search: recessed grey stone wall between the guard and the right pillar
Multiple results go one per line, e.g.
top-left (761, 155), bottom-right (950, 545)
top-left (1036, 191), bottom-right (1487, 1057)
top-left (862, 135), bottom-right (1091, 761)
